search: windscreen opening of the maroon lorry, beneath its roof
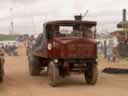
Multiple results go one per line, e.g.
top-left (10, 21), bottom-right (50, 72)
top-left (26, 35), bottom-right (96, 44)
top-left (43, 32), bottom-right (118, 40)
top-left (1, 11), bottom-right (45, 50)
top-left (55, 25), bottom-right (95, 38)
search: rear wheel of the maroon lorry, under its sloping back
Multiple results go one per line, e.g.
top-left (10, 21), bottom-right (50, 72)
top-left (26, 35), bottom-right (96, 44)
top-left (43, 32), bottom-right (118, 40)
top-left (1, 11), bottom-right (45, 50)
top-left (28, 56), bottom-right (41, 76)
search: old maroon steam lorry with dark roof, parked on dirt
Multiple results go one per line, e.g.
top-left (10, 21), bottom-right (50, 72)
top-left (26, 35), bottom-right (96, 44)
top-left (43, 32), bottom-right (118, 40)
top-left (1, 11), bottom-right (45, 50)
top-left (28, 15), bottom-right (98, 86)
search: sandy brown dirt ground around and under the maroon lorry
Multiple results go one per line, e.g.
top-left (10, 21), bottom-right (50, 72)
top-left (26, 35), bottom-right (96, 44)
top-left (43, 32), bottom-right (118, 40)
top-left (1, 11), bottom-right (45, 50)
top-left (0, 43), bottom-right (128, 96)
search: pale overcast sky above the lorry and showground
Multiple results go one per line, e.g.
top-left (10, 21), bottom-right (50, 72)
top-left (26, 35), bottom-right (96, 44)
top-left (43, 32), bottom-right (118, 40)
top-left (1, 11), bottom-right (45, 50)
top-left (0, 0), bottom-right (128, 33)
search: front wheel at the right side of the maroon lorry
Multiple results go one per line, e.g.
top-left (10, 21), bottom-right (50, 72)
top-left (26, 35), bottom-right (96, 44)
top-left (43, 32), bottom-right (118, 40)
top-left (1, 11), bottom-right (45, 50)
top-left (84, 64), bottom-right (98, 85)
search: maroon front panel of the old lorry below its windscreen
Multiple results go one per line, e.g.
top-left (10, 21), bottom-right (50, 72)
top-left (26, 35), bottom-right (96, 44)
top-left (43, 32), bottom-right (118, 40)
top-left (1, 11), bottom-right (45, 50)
top-left (48, 38), bottom-right (97, 59)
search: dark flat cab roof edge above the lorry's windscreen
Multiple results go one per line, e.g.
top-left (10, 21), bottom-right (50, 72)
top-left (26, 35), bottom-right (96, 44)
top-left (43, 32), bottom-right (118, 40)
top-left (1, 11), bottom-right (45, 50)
top-left (44, 20), bottom-right (97, 26)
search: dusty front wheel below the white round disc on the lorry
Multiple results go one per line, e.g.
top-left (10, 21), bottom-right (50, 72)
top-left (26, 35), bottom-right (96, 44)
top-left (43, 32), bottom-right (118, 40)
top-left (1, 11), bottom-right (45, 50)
top-left (48, 62), bottom-right (59, 87)
